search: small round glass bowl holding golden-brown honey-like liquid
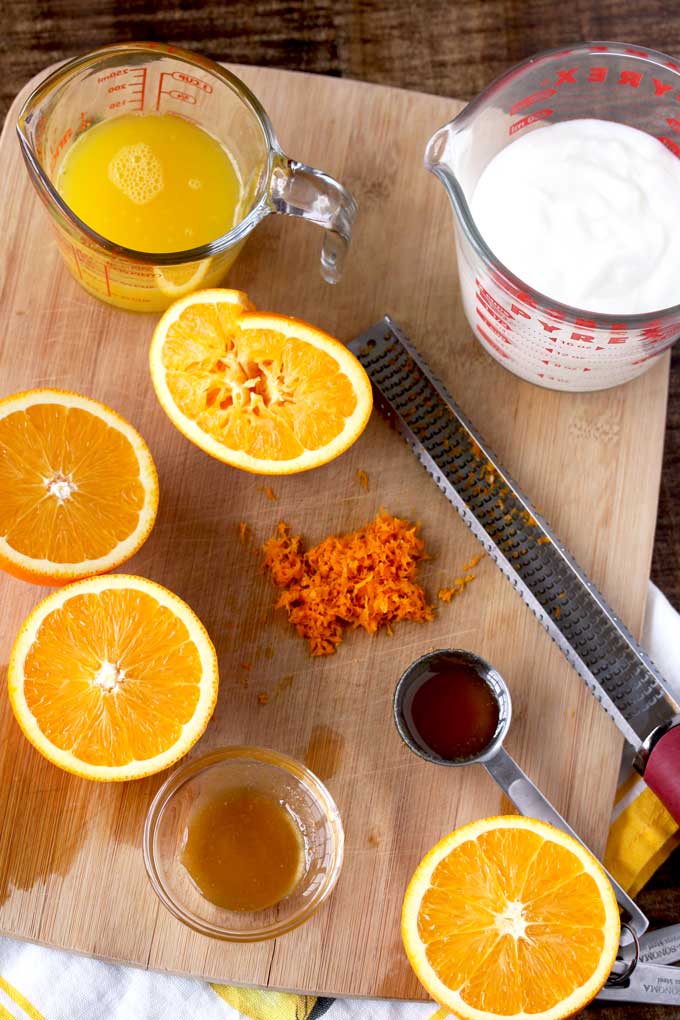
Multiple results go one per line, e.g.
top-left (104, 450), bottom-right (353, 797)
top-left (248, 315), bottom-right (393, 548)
top-left (144, 747), bottom-right (344, 941)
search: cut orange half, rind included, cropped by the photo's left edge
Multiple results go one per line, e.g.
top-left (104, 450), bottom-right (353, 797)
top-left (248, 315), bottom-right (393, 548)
top-left (0, 389), bottom-right (158, 584)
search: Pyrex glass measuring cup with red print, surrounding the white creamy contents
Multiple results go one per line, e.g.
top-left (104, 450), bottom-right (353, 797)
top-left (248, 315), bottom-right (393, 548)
top-left (425, 43), bottom-right (680, 391)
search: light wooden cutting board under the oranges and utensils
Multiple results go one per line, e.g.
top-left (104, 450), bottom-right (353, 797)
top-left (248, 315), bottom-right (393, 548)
top-left (0, 67), bottom-right (669, 998)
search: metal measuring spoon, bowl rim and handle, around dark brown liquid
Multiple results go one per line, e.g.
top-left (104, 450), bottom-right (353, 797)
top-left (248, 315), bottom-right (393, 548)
top-left (394, 649), bottom-right (649, 936)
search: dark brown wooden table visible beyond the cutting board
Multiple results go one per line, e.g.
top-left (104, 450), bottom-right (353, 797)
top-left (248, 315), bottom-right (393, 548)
top-left (0, 0), bottom-right (680, 1020)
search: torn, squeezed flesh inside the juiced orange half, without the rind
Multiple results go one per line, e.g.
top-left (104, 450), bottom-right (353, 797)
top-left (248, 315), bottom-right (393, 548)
top-left (162, 303), bottom-right (357, 461)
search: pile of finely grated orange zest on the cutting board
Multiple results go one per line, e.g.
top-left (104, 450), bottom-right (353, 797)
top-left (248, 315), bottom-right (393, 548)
top-left (263, 511), bottom-right (434, 656)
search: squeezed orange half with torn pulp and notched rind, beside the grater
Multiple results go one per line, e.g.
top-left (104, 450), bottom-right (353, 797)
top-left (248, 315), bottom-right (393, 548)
top-left (150, 290), bottom-right (372, 474)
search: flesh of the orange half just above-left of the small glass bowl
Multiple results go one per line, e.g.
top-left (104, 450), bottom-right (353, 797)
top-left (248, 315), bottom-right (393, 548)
top-left (23, 589), bottom-right (202, 766)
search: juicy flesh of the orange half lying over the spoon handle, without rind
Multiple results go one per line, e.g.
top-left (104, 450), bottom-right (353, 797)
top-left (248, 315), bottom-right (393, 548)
top-left (418, 829), bottom-right (606, 1016)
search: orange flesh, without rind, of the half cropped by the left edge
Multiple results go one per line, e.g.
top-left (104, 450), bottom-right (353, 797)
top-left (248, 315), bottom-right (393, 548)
top-left (0, 404), bottom-right (145, 563)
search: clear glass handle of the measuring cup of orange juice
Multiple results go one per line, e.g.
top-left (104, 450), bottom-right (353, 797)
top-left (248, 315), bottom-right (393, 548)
top-left (269, 154), bottom-right (357, 284)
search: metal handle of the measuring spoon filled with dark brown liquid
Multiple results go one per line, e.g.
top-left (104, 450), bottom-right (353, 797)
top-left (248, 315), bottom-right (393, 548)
top-left (482, 748), bottom-right (649, 936)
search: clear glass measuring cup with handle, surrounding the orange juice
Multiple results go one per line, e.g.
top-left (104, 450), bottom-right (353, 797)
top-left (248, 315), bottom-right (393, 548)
top-left (17, 43), bottom-right (357, 311)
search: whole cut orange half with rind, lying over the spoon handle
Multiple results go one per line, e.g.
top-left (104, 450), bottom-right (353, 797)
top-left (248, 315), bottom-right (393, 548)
top-left (402, 815), bottom-right (620, 1020)
